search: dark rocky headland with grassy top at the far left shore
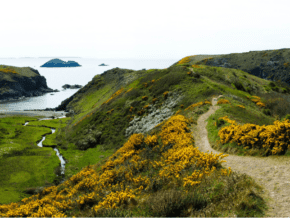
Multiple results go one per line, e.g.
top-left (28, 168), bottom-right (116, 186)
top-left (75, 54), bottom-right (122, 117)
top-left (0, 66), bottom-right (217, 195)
top-left (0, 65), bottom-right (56, 101)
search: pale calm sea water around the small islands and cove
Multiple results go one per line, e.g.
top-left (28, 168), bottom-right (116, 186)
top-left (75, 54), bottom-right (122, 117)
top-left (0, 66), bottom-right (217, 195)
top-left (0, 57), bottom-right (178, 111)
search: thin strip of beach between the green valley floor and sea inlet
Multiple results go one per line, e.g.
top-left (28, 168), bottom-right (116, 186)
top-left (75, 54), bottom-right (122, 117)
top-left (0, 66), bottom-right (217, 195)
top-left (0, 110), bottom-right (67, 118)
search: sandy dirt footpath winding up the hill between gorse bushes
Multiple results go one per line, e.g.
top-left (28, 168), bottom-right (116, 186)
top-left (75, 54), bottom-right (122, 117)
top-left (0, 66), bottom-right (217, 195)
top-left (192, 95), bottom-right (290, 217)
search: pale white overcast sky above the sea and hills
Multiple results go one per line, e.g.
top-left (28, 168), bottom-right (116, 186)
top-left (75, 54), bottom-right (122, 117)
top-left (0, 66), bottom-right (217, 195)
top-left (0, 0), bottom-right (290, 59)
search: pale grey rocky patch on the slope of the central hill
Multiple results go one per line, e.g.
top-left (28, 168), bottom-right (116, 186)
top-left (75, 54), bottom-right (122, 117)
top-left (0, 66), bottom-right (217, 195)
top-left (125, 89), bottom-right (183, 137)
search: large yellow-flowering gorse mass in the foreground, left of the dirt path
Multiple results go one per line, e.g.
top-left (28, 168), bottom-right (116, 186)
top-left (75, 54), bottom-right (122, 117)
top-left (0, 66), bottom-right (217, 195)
top-left (0, 102), bottom-right (231, 217)
